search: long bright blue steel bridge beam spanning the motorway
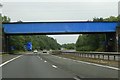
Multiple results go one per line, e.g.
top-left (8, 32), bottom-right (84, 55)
top-left (3, 22), bottom-right (117, 34)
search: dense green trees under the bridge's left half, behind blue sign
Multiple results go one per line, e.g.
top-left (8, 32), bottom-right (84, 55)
top-left (9, 35), bottom-right (60, 50)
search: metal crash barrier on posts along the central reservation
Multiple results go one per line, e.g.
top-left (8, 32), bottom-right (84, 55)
top-left (62, 52), bottom-right (120, 61)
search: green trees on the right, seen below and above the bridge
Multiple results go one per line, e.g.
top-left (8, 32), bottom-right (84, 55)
top-left (76, 16), bottom-right (120, 51)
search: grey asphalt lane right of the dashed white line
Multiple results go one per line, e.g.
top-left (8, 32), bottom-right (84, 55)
top-left (40, 54), bottom-right (119, 78)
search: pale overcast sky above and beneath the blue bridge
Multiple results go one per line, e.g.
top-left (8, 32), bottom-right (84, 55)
top-left (0, 0), bottom-right (120, 44)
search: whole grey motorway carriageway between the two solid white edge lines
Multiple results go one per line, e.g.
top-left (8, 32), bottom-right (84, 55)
top-left (2, 53), bottom-right (119, 79)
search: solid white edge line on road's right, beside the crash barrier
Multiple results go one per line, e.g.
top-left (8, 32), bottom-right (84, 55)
top-left (54, 55), bottom-right (120, 70)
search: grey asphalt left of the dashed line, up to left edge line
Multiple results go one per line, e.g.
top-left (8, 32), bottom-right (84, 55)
top-left (2, 54), bottom-right (74, 78)
